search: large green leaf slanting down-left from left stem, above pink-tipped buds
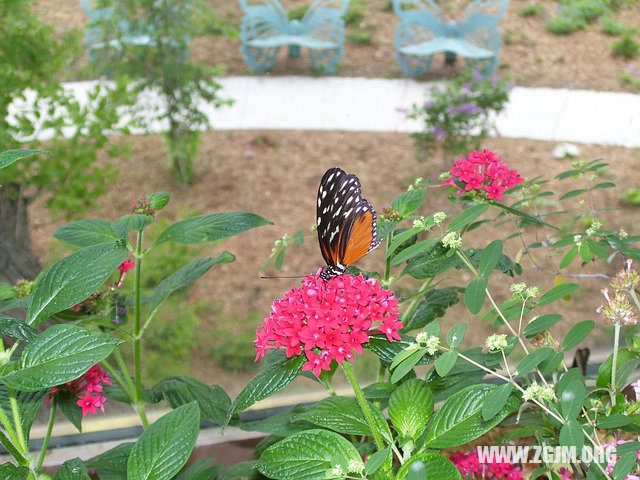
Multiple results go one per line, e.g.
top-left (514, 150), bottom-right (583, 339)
top-left (27, 243), bottom-right (128, 325)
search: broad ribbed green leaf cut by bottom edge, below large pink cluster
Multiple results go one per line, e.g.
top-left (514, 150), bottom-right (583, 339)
top-left (258, 430), bottom-right (364, 480)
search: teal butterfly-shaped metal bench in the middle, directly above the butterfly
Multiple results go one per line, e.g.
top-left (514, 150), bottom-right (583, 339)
top-left (238, 0), bottom-right (349, 73)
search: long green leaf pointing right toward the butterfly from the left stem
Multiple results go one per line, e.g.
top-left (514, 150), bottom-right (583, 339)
top-left (153, 212), bottom-right (273, 245)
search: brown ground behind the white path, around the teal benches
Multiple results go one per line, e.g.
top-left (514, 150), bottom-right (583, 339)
top-left (35, 0), bottom-right (640, 91)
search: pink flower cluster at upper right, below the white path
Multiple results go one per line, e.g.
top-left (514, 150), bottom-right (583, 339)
top-left (446, 150), bottom-right (524, 200)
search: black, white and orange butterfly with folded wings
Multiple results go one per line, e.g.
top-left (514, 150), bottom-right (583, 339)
top-left (316, 167), bottom-right (380, 280)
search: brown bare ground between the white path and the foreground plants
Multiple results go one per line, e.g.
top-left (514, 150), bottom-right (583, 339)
top-left (30, 131), bottom-right (640, 391)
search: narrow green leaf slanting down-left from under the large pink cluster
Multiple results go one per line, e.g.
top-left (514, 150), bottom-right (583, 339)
top-left (232, 352), bottom-right (306, 413)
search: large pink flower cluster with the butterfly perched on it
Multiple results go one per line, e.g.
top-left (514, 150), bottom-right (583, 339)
top-left (254, 271), bottom-right (402, 376)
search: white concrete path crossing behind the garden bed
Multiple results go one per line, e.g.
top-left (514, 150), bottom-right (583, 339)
top-left (15, 76), bottom-right (640, 147)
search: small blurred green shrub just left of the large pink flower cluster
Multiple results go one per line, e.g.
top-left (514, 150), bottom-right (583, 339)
top-left (211, 313), bottom-right (262, 372)
